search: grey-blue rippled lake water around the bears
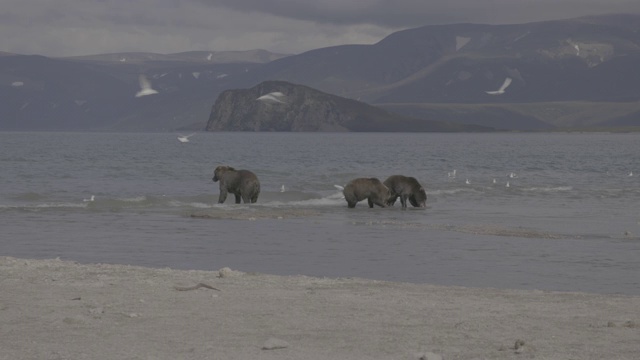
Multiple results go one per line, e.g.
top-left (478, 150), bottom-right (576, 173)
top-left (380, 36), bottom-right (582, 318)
top-left (0, 132), bottom-right (640, 294)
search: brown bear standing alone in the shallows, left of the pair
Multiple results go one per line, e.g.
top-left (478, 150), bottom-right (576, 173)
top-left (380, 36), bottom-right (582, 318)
top-left (213, 166), bottom-right (260, 204)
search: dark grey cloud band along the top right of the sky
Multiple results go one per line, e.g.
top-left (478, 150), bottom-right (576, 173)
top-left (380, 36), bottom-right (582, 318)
top-left (200, 0), bottom-right (640, 28)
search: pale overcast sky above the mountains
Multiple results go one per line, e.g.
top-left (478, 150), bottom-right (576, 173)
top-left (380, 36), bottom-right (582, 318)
top-left (0, 0), bottom-right (640, 56)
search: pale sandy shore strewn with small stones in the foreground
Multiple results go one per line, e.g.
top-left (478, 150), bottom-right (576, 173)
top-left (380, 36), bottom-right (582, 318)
top-left (0, 257), bottom-right (640, 360)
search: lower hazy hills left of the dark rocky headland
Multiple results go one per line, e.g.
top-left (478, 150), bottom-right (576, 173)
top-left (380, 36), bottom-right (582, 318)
top-left (0, 51), bottom-right (280, 131)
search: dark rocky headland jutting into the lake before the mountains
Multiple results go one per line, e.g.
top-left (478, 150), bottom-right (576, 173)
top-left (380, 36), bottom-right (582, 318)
top-left (206, 81), bottom-right (493, 132)
